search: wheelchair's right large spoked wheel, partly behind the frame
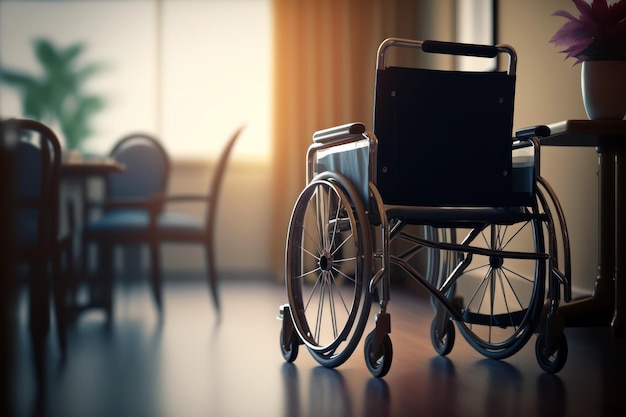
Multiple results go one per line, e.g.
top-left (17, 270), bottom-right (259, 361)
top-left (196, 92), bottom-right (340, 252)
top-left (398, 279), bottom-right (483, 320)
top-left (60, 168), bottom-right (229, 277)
top-left (449, 210), bottom-right (547, 359)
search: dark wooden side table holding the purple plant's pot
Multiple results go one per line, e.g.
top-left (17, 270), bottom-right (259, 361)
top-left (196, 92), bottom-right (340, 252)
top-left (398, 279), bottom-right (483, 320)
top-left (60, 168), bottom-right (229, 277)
top-left (540, 120), bottom-right (626, 337)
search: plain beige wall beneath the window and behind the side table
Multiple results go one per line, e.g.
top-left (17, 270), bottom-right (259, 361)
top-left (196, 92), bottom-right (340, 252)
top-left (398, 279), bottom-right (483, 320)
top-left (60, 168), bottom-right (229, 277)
top-left (151, 0), bottom-right (597, 292)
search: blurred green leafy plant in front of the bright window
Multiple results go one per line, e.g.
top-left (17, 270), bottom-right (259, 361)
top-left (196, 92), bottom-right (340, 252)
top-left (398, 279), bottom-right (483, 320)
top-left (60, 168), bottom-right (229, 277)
top-left (0, 39), bottom-right (105, 152)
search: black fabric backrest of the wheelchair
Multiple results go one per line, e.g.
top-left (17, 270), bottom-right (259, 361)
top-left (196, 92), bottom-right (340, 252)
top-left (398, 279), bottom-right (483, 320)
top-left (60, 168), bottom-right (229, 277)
top-left (374, 39), bottom-right (523, 206)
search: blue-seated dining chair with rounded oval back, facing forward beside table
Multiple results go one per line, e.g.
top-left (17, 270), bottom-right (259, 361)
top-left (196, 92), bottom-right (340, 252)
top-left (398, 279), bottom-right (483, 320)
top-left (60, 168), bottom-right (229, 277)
top-left (82, 133), bottom-right (170, 321)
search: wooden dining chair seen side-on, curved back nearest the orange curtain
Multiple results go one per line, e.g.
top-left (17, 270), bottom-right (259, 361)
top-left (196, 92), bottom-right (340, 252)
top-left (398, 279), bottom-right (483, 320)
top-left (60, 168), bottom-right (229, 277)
top-left (154, 126), bottom-right (244, 314)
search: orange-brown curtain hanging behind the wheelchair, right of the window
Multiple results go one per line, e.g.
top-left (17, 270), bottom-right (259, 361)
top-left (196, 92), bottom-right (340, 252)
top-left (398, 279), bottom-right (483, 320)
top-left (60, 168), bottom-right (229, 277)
top-left (271, 0), bottom-right (441, 279)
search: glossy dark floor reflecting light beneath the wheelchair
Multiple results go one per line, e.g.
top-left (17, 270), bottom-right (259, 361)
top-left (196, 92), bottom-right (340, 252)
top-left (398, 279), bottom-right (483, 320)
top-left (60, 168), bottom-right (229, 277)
top-left (6, 272), bottom-right (626, 417)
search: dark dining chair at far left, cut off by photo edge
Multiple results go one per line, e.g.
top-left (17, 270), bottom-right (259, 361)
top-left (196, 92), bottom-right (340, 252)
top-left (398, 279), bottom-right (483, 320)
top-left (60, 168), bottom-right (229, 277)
top-left (2, 119), bottom-right (73, 377)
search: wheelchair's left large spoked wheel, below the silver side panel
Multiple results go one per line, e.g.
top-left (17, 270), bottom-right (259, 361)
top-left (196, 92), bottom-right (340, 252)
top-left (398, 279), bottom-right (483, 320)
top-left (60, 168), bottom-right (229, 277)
top-left (285, 172), bottom-right (372, 367)
